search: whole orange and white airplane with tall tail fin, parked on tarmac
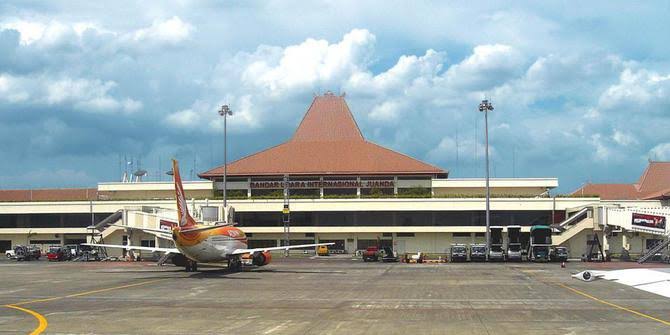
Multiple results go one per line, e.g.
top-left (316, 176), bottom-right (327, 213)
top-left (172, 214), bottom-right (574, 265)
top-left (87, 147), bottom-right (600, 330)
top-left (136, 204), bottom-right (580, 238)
top-left (84, 160), bottom-right (335, 271)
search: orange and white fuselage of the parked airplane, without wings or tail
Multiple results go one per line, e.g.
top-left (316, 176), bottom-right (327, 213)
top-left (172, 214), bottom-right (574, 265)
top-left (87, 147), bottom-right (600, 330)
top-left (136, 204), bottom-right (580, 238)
top-left (172, 225), bottom-right (247, 263)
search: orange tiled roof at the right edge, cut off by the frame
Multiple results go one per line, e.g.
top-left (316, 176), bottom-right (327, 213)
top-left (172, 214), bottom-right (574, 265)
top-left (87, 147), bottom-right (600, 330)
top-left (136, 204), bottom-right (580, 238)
top-left (573, 161), bottom-right (670, 200)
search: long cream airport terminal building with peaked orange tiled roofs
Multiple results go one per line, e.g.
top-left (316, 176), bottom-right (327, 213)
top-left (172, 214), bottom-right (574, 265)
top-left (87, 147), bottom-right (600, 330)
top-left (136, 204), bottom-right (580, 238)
top-left (0, 93), bottom-right (670, 257)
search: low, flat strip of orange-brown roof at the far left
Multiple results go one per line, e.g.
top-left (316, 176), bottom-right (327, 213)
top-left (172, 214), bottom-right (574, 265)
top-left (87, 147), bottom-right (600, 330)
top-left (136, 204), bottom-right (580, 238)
top-left (0, 188), bottom-right (98, 202)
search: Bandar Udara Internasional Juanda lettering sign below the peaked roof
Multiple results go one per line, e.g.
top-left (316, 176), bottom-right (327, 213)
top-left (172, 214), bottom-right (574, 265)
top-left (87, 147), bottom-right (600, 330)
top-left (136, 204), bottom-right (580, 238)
top-left (251, 179), bottom-right (395, 189)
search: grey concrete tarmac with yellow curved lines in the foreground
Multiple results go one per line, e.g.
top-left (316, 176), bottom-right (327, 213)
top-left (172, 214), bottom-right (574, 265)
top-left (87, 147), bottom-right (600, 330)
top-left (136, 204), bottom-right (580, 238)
top-left (0, 256), bottom-right (670, 335)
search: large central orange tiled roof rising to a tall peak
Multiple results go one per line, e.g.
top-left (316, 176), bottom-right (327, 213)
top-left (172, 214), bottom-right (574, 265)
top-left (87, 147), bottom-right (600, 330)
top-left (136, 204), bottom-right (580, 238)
top-left (200, 94), bottom-right (447, 178)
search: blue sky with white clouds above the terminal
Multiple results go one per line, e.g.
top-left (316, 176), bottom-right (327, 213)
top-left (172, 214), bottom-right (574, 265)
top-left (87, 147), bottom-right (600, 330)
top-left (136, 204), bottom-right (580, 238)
top-left (0, 1), bottom-right (670, 192)
